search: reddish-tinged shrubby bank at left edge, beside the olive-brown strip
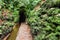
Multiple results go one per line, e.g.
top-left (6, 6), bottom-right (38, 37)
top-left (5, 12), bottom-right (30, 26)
top-left (0, 9), bottom-right (14, 40)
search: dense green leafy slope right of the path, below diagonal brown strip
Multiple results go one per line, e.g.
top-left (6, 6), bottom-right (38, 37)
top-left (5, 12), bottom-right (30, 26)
top-left (27, 0), bottom-right (60, 40)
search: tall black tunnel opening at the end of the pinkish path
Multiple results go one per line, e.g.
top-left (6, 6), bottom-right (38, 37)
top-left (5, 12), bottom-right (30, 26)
top-left (19, 6), bottom-right (26, 24)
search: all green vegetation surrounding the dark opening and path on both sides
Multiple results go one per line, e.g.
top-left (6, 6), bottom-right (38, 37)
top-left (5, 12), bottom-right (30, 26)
top-left (0, 0), bottom-right (60, 40)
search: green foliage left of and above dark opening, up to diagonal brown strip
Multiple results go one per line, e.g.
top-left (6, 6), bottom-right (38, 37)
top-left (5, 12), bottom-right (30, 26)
top-left (0, 0), bottom-right (40, 40)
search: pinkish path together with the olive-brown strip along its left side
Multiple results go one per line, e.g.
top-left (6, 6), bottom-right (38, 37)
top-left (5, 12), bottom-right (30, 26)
top-left (3, 23), bottom-right (33, 40)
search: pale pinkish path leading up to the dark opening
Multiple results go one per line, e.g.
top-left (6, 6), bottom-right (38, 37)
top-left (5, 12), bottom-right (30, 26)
top-left (16, 23), bottom-right (33, 40)
